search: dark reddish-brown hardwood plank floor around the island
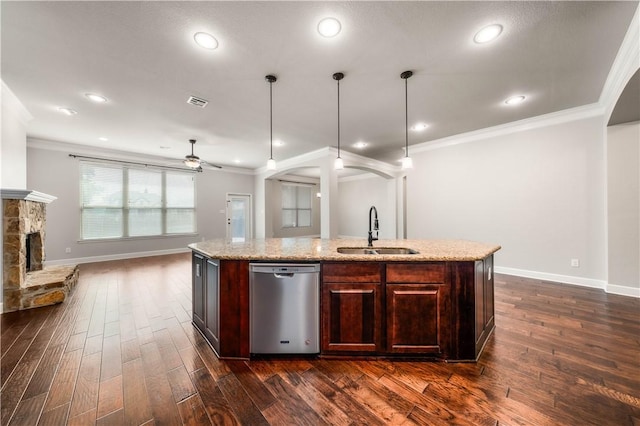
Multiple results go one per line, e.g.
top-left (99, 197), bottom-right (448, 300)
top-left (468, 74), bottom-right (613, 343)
top-left (0, 254), bottom-right (640, 425)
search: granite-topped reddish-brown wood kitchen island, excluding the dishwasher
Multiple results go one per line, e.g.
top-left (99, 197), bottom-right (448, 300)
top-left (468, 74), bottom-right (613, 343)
top-left (189, 238), bottom-right (500, 361)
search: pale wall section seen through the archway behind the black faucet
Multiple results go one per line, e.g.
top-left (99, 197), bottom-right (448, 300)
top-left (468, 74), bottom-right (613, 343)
top-left (338, 173), bottom-right (396, 240)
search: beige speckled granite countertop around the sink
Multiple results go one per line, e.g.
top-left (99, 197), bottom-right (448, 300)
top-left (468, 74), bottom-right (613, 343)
top-left (189, 238), bottom-right (500, 262)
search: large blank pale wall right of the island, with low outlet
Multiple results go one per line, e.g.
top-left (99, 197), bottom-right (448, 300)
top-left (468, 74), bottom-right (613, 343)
top-left (407, 116), bottom-right (607, 288)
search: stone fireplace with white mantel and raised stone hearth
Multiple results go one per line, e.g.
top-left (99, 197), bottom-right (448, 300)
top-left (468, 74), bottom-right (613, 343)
top-left (1, 189), bottom-right (78, 312)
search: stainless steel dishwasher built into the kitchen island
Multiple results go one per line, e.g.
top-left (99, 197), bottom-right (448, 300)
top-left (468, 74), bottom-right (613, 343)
top-left (249, 263), bottom-right (320, 354)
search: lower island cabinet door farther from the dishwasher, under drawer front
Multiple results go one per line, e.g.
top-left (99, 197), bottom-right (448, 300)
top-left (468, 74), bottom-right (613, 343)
top-left (386, 283), bottom-right (451, 354)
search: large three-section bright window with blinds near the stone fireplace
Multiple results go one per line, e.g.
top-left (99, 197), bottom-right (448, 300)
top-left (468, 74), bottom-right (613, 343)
top-left (80, 162), bottom-right (196, 240)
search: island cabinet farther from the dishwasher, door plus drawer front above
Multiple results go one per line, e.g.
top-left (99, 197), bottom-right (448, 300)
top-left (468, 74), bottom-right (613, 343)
top-left (386, 262), bottom-right (451, 356)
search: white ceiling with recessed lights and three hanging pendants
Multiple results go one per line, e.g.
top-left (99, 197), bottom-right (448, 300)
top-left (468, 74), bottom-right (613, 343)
top-left (1, 1), bottom-right (638, 168)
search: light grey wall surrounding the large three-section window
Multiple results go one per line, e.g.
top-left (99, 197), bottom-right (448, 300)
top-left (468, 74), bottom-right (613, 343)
top-left (27, 148), bottom-right (253, 264)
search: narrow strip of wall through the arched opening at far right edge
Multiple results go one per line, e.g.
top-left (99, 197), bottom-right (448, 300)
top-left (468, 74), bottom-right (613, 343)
top-left (607, 121), bottom-right (640, 297)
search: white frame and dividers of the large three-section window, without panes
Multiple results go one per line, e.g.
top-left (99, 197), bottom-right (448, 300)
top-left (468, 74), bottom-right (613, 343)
top-left (78, 161), bottom-right (198, 243)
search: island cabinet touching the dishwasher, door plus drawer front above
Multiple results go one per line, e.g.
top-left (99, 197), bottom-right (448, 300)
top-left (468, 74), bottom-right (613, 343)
top-left (321, 262), bottom-right (383, 353)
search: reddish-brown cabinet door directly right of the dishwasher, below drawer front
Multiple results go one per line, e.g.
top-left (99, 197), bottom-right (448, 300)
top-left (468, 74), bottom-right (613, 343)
top-left (322, 283), bottom-right (382, 353)
